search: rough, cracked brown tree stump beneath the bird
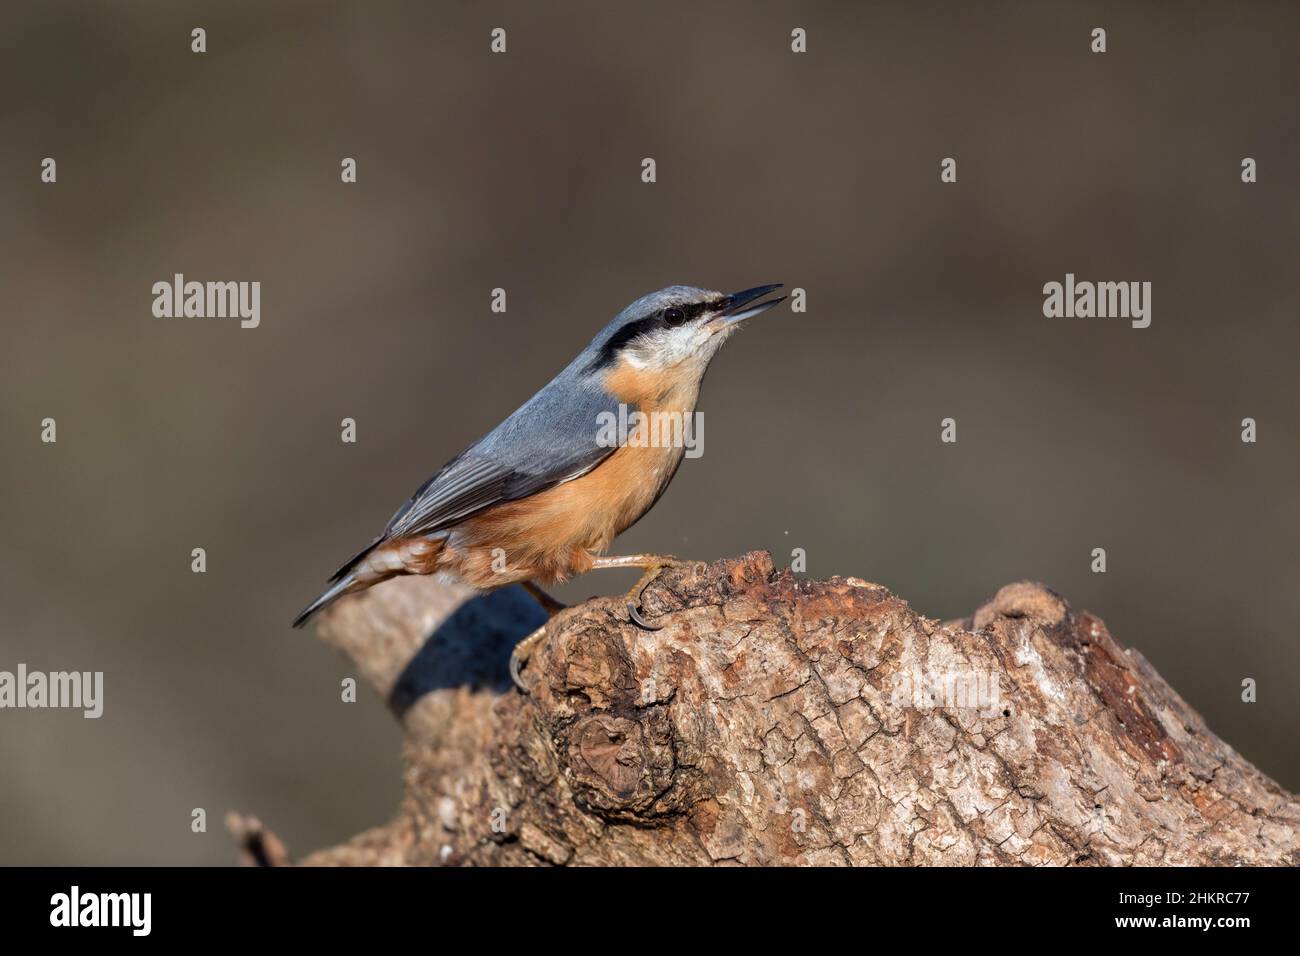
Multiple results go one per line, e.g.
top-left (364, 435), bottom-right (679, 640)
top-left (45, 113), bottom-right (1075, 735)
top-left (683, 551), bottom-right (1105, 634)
top-left (269, 553), bottom-right (1300, 865)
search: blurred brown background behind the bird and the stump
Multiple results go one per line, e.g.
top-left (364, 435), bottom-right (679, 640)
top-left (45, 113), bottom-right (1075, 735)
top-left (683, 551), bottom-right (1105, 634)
top-left (0, 3), bottom-right (1300, 864)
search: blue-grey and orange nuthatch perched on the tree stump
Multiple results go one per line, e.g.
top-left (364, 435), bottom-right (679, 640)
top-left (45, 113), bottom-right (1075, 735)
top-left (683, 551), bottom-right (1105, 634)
top-left (294, 284), bottom-right (785, 687)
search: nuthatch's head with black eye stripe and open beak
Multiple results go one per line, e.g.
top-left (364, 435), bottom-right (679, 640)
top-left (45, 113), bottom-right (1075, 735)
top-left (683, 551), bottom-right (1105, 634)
top-left (589, 282), bottom-right (785, 380)
